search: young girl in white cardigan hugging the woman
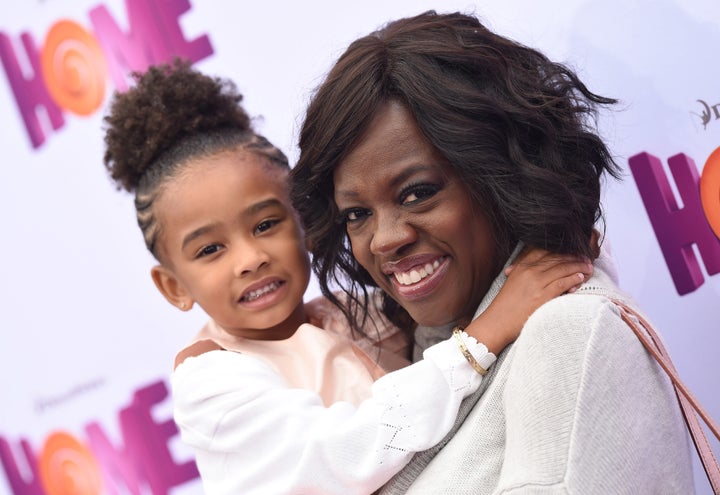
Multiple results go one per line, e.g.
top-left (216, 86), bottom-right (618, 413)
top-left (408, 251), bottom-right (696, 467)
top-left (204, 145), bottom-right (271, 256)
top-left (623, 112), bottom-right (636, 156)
top-left (105, 62), bottom-right (591, 495)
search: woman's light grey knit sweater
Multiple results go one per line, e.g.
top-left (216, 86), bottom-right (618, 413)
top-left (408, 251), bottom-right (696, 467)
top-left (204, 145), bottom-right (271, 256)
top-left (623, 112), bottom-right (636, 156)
top-left (382, 248), bottom-right (694, 495)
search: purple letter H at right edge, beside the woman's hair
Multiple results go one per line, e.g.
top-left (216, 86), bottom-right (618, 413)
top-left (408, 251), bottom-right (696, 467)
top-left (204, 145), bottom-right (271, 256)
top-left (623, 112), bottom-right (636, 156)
top-left (629, 152), bottom-right (720, 295)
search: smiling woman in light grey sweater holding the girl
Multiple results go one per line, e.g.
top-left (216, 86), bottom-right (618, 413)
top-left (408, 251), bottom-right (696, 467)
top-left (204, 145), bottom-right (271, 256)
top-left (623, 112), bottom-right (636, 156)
top-left (292, 8), bottom-right (693, 494)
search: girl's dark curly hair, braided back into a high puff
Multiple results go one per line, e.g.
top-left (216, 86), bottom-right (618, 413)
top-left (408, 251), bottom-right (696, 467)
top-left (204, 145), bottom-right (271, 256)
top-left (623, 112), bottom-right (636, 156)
top-left (104, 59), bottom-right (289, 260)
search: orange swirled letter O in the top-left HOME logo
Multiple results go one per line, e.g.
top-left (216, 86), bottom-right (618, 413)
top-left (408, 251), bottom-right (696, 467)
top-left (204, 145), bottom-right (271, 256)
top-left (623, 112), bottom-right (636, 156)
top-left (41, 20), bottom-right (108, 115)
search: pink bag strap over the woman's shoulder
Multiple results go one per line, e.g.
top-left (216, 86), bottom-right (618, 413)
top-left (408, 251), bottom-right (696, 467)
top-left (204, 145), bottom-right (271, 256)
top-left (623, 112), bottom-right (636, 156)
top-left (612, 299), bottom-right (720, 495)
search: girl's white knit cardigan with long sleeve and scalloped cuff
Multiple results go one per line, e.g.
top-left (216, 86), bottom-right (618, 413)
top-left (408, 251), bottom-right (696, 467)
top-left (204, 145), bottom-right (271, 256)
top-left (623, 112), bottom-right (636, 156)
top-left (172, 338), bottom-right (494, 495)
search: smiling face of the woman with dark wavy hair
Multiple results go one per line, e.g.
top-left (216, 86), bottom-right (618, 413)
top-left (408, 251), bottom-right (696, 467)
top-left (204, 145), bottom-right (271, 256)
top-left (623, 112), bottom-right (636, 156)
top-left (334, 102), bottom-right (498, 326)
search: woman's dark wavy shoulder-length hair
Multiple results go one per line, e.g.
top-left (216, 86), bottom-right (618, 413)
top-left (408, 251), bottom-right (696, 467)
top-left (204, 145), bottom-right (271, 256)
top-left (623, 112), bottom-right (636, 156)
top-left (292, 11), bottom-right (620, 334)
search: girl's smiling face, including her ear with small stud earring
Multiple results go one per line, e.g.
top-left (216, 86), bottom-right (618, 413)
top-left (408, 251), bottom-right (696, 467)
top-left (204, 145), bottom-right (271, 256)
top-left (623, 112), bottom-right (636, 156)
top-left (153, 150), bottom-right (310, 340)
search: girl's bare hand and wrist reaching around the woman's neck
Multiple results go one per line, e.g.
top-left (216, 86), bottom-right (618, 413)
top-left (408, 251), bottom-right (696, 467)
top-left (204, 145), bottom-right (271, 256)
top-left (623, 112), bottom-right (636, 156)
top-left (465, 248), bottom-right (593, 355)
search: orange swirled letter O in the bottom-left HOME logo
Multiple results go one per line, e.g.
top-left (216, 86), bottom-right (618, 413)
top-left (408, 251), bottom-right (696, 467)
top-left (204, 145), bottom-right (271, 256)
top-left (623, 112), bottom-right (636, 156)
top-left (38, 432), bottom-right (103, 495)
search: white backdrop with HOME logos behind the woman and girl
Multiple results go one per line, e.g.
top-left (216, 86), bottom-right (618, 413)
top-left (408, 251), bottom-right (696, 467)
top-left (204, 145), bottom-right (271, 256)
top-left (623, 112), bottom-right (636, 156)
top-left (0, 0), bottom-right (720, 495)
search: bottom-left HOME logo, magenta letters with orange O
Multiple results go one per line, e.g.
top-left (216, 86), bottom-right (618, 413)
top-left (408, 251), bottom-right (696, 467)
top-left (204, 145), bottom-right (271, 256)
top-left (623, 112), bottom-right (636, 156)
top-left (0, 381), bottom-right (199, 495)
